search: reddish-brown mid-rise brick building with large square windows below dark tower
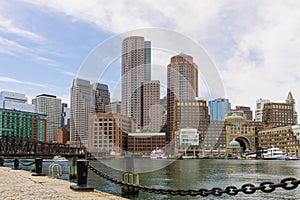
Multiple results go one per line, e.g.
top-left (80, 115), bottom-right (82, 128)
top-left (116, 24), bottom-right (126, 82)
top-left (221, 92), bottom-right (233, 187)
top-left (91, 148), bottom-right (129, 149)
top-left (88, 113), bottom-right (136, 157)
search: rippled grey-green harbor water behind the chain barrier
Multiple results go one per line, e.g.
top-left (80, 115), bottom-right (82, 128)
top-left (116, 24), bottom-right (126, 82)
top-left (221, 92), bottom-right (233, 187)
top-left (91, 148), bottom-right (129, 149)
top-left (6, 158), bottom-right (300, 200)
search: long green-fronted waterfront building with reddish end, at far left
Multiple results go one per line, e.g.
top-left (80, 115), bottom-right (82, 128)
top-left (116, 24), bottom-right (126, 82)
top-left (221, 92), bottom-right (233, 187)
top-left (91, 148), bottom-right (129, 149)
top-left (0, 108), bottom-right (47, 142)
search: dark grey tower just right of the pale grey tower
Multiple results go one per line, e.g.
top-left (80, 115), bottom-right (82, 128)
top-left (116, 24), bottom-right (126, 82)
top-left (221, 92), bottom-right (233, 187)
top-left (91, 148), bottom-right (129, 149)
top-left (92, 83), bottom-right (110, 113)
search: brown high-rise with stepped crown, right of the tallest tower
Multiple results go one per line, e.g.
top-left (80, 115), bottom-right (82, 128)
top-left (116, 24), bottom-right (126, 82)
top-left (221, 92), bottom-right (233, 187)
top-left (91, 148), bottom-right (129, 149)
top-left (166, 54), bottom-right (198, 143)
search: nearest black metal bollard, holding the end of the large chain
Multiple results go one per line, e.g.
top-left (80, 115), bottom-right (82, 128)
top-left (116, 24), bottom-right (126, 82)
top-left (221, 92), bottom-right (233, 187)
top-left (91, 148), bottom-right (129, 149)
top-left (70, 160), bottom-right (94, 191)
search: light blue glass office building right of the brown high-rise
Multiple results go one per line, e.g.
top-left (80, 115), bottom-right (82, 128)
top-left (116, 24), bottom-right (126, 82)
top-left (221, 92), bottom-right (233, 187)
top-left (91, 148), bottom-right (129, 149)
top-left (208, 98), bottom-right (231, 120)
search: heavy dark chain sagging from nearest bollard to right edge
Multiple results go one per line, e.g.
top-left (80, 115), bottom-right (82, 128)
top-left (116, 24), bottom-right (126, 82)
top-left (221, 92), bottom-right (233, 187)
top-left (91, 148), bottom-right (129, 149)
top-left (87, 164), bottom-right (300, 197)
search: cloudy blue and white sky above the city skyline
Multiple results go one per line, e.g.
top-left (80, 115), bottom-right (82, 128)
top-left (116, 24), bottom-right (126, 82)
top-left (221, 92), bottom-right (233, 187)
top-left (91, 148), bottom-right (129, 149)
top-left (0, 0), bottom-right (300, 116)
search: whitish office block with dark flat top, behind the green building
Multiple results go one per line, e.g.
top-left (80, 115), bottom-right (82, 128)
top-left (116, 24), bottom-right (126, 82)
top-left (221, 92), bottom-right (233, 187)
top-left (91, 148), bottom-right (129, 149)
top-left (32, 94), bottom-right (61, 142)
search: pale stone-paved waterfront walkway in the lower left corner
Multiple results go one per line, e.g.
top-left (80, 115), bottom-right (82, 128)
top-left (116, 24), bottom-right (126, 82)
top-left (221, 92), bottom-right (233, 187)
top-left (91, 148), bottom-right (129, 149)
top-left (0, 167), bottom-right (124, 200)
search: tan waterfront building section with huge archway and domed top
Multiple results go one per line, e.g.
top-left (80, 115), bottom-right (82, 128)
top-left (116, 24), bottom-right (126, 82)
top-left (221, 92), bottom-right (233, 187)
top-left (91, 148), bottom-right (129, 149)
top-left (225, 112), bottom-right (256, 151)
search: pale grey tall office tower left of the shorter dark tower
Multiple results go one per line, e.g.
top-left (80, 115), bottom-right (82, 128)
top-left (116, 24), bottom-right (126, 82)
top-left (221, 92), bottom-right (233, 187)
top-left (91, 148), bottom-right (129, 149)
top-left (70, 78), bottom-right (95, 146)
